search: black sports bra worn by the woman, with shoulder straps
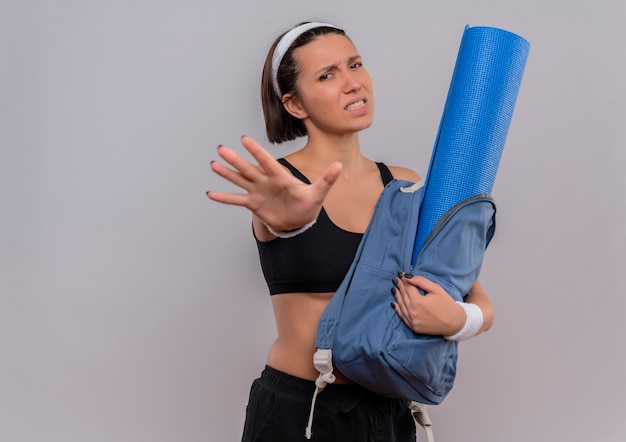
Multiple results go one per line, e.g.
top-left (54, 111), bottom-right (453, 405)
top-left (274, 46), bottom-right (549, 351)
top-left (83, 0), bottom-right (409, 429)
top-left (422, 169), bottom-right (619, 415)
top-left (256, 158), bottom-right (393, 295)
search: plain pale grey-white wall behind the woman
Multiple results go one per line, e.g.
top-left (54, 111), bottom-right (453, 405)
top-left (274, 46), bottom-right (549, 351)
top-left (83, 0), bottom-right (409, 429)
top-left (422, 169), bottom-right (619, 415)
top-left (0, 0), bottom-right (626, 442)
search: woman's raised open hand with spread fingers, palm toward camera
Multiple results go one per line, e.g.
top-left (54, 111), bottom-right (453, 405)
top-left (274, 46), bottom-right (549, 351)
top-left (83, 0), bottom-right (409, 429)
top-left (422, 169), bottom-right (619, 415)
top-left (207, 136), bottom-right (343, 231)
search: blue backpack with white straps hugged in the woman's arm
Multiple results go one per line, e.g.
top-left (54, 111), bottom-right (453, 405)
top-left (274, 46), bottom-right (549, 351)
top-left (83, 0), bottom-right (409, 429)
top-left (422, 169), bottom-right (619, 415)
top-left (306, 180), bottom-right (496, 440)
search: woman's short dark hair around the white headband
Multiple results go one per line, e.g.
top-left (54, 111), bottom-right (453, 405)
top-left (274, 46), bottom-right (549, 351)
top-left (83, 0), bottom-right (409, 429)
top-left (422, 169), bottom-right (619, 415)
top-left (261, 22), bottom-right (346, 143)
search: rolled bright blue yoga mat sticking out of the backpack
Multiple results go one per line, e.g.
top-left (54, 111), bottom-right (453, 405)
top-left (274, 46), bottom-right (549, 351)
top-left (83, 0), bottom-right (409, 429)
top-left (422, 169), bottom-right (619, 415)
top-left (413, 26), bottom-right (530, 262)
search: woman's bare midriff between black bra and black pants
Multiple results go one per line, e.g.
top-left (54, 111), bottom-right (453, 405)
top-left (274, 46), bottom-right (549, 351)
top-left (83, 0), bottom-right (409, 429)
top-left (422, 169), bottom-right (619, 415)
top-left (267, 293), bottom-right (351, 384)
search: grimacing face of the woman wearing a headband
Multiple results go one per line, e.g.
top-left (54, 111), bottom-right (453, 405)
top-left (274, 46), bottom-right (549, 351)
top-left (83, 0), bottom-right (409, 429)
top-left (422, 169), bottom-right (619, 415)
top-left (288, 34), bottom-right (374, 135)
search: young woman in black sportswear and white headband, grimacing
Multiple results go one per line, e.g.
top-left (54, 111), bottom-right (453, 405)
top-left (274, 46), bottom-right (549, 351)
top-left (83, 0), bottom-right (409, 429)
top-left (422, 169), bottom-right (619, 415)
top-left (208, 23), bottom-right (493, 442)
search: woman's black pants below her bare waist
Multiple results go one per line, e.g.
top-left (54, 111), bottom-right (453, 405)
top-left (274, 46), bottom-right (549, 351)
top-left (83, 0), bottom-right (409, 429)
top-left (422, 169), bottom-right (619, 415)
top-left (242, 367), bottom-right (415, 442)
